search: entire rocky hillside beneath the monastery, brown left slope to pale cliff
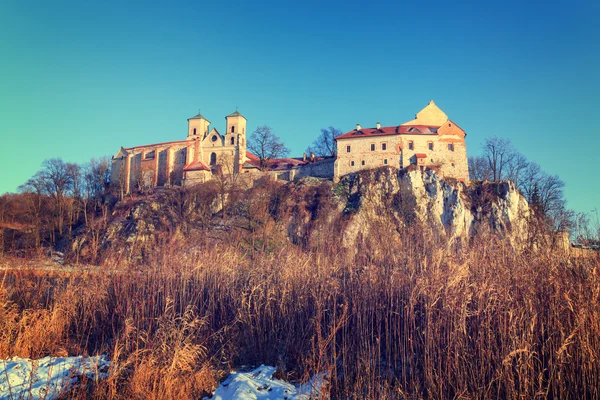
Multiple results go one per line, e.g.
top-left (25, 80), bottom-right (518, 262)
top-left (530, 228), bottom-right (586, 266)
top-left (88, 167), bottom-right (531, 258)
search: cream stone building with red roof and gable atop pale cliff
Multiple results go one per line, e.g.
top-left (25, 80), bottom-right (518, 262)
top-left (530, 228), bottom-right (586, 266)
top-left (335, 100), bottom-right (469, 183)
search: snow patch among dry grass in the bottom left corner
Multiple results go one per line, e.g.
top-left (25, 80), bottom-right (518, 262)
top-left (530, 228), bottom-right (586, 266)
top-left (0, 356), bottom-right (109, 400)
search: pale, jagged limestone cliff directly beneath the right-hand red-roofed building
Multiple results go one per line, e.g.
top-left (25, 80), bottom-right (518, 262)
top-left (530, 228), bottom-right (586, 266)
top-left (338, 168), bottom-right (531, 248)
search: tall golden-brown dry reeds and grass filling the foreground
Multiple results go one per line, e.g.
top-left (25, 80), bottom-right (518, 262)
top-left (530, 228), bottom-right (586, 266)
top-left (0, 203), bottom-right (600, 399)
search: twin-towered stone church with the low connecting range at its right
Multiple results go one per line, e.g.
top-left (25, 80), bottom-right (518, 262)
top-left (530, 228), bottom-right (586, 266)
top-left (111, 111), bottom-right (335, 193)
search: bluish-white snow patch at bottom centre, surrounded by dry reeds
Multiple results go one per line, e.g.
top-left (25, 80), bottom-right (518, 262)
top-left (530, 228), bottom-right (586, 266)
top-left (204, 365), bottom-right (323, 400)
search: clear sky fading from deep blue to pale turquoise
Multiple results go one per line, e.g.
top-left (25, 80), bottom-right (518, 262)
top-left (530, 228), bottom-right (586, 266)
top-left (0, 0), bottom-right (600, 216)
